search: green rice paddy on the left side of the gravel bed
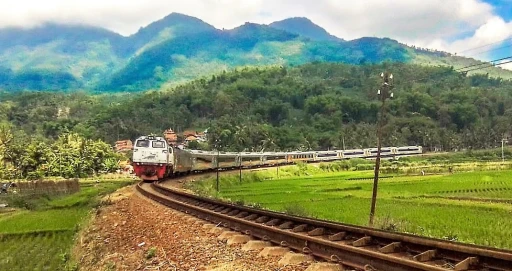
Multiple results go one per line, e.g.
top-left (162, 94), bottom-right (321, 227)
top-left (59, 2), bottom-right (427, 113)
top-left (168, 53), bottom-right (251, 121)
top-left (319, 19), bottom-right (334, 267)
top-left (0, 179), bottom-right (133, 270)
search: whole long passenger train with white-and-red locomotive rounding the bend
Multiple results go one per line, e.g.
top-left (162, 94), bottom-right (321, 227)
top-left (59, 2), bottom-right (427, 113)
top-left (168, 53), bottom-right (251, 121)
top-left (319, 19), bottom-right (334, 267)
top-left (132, 136), bottom-right (423, 181)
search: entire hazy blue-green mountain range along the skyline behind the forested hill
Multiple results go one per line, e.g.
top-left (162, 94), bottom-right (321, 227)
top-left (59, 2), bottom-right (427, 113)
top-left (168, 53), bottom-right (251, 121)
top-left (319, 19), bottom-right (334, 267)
top-left (0, 13), bottom-right (512, 92)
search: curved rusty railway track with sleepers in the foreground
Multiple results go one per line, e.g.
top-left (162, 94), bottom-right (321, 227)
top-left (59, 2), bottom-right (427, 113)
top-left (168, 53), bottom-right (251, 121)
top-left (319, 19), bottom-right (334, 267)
top-left (137, 182), bottom-right (512, 271)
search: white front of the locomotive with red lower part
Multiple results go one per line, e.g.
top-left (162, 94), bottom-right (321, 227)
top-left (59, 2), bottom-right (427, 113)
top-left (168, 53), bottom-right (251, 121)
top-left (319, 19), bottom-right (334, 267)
top-left (132, 136), bottom-right (172, 181)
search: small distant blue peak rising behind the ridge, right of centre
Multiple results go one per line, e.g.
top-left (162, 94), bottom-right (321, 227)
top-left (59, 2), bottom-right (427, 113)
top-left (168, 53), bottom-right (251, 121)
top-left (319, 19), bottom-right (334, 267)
top-left (269, 17), bottom-right (342, 41)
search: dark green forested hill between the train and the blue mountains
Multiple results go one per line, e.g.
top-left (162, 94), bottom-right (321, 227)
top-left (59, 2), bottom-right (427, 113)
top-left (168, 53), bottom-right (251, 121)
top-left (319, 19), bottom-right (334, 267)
top-left (0, 63), bottom-right (512, 151)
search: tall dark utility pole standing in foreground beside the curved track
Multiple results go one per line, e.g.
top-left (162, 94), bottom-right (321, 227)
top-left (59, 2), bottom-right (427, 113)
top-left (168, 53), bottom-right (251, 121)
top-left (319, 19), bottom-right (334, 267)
top-left (368, 72), bottom-right (393, 227)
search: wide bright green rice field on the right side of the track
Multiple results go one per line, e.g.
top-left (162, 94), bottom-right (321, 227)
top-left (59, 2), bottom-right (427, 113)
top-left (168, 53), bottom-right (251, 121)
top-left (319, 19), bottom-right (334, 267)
top-left (193, 165), bottom-right (512, 249)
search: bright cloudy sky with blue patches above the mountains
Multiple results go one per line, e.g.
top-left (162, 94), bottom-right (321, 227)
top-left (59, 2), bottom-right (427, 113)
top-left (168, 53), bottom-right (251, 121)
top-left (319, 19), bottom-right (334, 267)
top-left (0, 0), bottom-right (512, 68)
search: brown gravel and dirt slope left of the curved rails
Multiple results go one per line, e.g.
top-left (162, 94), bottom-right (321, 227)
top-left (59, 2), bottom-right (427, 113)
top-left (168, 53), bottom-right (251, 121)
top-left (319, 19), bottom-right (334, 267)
top-left (76, 186), bottom-right (307, 271)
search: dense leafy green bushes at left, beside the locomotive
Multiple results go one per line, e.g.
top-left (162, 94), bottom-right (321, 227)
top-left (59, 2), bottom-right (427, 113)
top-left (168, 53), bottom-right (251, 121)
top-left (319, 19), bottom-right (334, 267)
top-left (0, 126), bottom-right (120, 180)
